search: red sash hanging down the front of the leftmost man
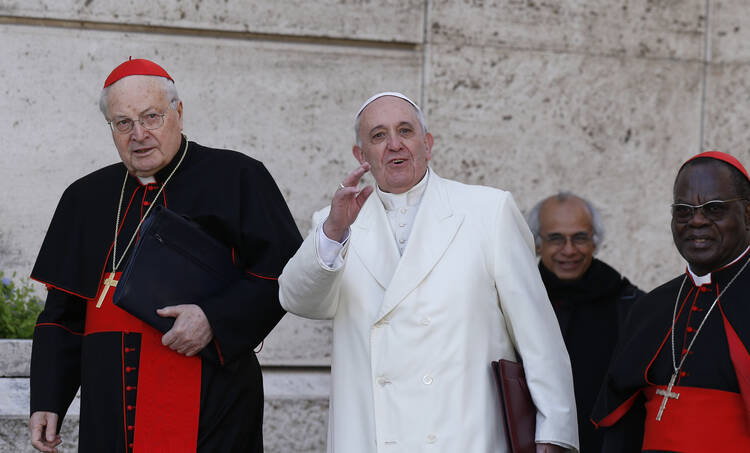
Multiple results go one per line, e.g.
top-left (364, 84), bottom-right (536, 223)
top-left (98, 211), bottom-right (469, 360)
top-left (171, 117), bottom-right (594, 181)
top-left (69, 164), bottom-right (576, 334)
top-left (85, 272), bottom-right (201, 453)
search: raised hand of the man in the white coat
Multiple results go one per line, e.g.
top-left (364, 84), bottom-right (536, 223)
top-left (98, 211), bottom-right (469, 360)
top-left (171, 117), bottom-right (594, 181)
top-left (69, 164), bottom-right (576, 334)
top-left (323, 162), bottom-right (374, 242)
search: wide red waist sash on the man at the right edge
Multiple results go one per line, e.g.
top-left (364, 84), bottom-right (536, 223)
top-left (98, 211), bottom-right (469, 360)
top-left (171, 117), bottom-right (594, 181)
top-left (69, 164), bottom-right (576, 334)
top-left (643, 386), bottom-right (750, 453)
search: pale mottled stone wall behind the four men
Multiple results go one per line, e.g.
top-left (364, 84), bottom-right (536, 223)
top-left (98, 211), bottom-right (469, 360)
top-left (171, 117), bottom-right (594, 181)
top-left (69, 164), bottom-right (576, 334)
top-left (0, 0), bottom-right (750, 451)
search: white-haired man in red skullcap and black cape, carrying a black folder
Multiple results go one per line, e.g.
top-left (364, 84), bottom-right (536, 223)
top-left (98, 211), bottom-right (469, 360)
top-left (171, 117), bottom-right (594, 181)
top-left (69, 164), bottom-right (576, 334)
top-left (30, 60), bottom-right (301, 453)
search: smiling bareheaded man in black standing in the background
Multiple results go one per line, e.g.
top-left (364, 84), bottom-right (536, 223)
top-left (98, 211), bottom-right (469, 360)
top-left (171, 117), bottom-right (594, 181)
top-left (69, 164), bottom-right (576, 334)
top-left (527, 192), bottom-right (643, 453)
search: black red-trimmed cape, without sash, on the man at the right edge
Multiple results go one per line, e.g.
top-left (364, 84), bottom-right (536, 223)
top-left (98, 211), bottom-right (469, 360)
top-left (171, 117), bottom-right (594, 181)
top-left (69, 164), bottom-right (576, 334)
top-left (592, 249), bottom-right (750, 452)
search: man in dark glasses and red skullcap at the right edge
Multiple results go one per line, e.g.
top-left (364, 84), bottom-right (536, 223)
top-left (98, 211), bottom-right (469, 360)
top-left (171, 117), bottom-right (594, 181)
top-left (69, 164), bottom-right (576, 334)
top-left (592, 151), bottom-right (750, 452)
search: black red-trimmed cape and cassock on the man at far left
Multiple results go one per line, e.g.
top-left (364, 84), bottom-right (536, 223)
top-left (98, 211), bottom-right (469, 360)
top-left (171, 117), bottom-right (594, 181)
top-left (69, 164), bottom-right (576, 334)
top-left (31, 138), bottom-right (301, 453)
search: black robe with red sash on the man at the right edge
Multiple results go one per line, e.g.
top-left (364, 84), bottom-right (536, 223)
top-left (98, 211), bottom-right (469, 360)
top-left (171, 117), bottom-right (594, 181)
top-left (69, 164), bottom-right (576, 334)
top-left (592, 254), bottom-right (750, 453)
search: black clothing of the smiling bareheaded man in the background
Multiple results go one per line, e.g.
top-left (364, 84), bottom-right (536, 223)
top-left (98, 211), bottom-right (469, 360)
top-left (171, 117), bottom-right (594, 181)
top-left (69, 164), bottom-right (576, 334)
top-left (539, 259), bottom-right (644, 453)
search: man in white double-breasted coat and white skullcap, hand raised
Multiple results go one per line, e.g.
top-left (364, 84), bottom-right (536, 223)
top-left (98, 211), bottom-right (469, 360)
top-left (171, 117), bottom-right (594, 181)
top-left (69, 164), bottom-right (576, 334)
top-left (279, 92), bottom-right (578, 453)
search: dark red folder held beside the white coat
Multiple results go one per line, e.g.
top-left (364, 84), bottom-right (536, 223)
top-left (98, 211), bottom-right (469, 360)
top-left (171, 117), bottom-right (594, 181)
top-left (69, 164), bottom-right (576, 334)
top-left (492, 359), bottom-right (536, 453)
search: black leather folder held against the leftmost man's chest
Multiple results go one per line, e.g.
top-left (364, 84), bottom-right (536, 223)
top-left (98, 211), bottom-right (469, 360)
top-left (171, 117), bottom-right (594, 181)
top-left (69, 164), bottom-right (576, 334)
top-left (113, 206), bottom-right (242, 359)
